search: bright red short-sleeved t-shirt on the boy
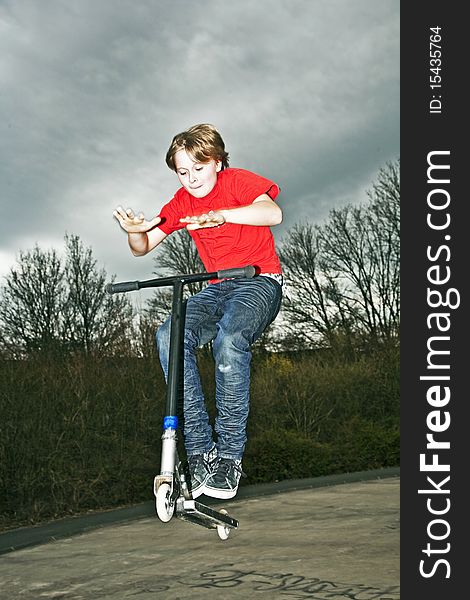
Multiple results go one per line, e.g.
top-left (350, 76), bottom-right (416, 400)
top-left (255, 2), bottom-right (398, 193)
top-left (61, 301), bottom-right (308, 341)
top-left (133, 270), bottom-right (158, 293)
top-left (158, 168), bottom-right (281, 273)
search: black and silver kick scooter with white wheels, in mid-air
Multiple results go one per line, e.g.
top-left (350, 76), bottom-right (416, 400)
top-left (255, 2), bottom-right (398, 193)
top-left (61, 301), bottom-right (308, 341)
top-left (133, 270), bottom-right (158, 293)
top-left (106, 266), bottom-right (255, 540)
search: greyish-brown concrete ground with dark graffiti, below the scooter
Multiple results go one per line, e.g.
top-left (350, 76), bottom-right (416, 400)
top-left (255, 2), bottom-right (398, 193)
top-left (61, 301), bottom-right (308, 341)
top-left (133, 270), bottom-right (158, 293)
top-left (0, 476), bottom-right (400, 600)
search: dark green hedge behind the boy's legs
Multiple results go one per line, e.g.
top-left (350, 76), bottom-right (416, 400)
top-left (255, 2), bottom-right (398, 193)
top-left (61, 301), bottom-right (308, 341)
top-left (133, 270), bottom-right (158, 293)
top-left (0, 349), bottom-right (399, 528)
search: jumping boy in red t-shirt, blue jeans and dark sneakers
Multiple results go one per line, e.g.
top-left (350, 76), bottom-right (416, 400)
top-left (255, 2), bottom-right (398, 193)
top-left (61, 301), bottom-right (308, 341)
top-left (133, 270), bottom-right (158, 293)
top-left (113, 124), bottom-right (282, 499)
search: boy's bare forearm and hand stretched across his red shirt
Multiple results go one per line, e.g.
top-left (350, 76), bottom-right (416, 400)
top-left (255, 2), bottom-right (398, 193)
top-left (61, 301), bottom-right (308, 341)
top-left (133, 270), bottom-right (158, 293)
top-left (180, 194), bottom-right (282, 229)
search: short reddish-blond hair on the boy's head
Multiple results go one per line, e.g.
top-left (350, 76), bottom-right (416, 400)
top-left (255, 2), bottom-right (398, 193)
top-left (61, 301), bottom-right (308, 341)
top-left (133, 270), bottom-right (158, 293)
top-left (165, 124), bottom-right (228, 171)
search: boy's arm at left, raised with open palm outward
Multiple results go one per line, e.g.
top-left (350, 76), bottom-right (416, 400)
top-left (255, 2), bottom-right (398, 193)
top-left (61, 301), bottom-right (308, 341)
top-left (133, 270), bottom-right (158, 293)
top-left (113, 206), bottom-right (167, 256)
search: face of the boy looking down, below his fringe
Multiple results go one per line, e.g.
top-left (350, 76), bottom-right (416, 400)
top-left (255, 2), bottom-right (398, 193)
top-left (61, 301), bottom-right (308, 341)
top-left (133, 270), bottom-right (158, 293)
top-left (174, 150), bottom-right (222, 198)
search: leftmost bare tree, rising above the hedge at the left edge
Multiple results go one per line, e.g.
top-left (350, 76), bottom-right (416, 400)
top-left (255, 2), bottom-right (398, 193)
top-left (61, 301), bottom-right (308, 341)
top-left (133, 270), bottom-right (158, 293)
top-left (0, 245), bottom-right (65, 356)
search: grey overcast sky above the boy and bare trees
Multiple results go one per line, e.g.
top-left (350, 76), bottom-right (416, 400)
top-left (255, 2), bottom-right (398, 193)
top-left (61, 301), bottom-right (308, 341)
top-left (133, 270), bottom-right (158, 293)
top-left (0, 0), bottom-right (399, 288)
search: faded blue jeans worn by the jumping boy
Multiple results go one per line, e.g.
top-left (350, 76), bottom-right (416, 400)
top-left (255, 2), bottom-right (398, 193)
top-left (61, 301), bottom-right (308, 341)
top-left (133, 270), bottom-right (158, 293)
top-left (157, 276), bottom-right (282, 459)
